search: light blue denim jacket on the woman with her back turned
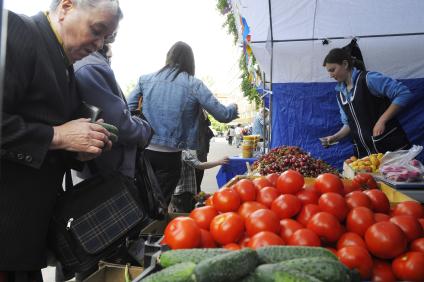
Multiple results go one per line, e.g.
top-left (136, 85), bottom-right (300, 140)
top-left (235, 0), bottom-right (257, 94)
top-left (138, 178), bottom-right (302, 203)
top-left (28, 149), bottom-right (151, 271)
top-left (128, 69), bottom-right (237, 150)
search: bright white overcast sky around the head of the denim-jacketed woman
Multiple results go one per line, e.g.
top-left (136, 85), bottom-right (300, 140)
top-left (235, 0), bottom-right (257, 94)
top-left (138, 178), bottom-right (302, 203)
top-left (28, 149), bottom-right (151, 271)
top-left (5, 0), bottom-right (241, 96)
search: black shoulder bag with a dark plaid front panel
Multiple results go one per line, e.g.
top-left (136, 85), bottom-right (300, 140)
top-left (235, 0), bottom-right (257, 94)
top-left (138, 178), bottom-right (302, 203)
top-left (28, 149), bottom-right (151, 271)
top-left (48, 172), bottom-right (150, 273)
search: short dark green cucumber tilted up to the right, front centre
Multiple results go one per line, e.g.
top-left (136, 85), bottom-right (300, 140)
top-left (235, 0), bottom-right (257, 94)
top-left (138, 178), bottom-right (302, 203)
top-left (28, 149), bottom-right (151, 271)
top-left (194, 248), bottom-right (259, 282)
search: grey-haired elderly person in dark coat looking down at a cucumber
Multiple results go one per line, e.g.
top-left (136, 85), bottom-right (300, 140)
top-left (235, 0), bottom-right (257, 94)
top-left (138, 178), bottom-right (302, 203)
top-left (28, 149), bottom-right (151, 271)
top-left (0, 0), bottom-right (121, 281)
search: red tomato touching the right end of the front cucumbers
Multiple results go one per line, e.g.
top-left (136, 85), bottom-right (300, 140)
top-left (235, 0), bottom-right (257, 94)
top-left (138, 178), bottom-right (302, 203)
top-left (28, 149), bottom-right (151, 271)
top-left (337, 246), bottom-right (373, 280)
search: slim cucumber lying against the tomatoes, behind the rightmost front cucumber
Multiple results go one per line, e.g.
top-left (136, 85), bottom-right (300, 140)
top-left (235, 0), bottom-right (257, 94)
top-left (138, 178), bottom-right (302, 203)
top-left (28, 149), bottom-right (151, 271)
top-left (256, 246), bottom-right (337, 263)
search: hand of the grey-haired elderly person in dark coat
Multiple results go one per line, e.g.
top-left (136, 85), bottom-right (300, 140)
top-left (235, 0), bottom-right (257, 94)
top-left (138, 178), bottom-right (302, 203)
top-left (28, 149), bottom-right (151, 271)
top-left (50, 118), bottom-right (111, 155)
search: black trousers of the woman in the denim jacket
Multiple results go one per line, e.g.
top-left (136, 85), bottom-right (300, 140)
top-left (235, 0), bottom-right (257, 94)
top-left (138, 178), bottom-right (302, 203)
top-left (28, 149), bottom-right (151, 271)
top-left (144, 149), bottom-right (181, 205)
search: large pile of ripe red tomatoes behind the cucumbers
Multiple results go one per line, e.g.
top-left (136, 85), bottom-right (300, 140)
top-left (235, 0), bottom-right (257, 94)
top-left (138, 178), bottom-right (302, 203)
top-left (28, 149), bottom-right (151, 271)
top-left (164, 170), bottom-right (424, 281)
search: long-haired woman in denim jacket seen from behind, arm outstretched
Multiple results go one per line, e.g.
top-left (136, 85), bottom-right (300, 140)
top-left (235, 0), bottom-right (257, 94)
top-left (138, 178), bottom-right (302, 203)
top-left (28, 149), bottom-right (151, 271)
top-left (128, 41), bottom-right (238, 204)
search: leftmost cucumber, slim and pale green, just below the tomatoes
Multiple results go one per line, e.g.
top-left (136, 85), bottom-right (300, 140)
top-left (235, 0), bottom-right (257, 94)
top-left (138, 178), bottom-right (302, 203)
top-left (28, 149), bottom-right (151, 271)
top-left (159, 248), bottom-right (230, 267)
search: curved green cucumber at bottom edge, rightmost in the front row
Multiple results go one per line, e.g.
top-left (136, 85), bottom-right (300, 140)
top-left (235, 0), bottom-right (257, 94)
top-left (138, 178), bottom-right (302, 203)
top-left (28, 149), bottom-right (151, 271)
top-left (255, 257), bottom-right (352, 282)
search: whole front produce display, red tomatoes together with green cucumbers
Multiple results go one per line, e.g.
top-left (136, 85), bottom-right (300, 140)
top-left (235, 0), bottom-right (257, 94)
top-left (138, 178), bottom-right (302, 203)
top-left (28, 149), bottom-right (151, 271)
top-left (134, 170), bottom-right (424, 282)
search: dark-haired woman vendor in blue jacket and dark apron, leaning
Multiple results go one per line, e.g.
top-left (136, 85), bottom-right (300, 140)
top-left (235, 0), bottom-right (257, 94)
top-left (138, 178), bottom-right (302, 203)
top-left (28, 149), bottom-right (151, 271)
top-left (320, 48), bottom-right (413, 158)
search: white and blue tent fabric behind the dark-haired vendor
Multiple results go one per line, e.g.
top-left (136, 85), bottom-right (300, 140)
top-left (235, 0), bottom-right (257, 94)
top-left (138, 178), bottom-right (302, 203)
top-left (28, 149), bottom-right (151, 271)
top-left (231, 0), bottom-right (424, 166)
